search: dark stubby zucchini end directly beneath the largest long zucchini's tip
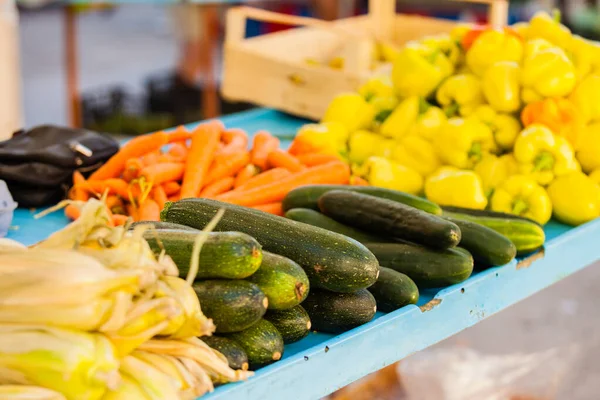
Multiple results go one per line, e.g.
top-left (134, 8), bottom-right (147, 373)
top-left (302, 289), bottom-right (377, 334)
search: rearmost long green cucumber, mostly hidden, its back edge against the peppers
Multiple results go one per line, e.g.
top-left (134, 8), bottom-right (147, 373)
top-left (282, 185), bottom-right (442, 215)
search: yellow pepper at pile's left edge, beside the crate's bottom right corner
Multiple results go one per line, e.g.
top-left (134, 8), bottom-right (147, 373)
top-left (322, 93), bottom-right (375, 132)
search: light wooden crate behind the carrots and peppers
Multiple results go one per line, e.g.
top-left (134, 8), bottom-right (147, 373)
top-left (221, 0), bottom-right (508, 120)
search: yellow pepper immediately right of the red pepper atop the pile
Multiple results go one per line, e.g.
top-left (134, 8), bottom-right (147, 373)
top-left (466, 29), bottom-right (523, 76)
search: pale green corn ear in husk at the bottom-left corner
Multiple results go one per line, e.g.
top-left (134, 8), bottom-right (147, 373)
top-left (0, 324), bottom-right (120, 400)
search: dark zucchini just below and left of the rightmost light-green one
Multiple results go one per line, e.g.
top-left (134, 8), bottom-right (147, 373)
top-left (443, 216), bottom-right (517, 267)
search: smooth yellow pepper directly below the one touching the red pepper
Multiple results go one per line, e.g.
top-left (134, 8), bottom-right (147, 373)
top-left (481, 61), bottom-right (521, 113)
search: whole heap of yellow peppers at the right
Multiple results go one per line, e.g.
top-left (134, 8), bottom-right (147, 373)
top-left (294, 12), bottom-right (600, 225)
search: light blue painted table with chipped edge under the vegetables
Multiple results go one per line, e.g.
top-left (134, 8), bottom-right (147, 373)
top-left (9, 109), bottom-right (600, 400)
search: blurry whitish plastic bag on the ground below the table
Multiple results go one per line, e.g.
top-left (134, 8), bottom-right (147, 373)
top-left (398, 346), bottom-right (578, 400)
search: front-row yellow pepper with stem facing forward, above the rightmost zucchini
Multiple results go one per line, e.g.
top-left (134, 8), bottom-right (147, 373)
top-left (491, 175), bottom-right (552, 225)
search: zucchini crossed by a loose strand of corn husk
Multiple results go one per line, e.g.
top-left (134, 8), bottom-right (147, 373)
top-left (144, 229), bottom-right (262, 279)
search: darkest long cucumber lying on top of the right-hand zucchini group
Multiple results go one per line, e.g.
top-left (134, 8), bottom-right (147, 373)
top-left (319, 190), bottom-right (460, 249)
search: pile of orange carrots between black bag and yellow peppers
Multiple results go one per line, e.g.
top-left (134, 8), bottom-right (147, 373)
top-left (65, 120), bottom-right (364, 225)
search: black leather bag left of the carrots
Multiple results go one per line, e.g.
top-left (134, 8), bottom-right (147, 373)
top-left (0, 125), bottom-right (119, 207)
